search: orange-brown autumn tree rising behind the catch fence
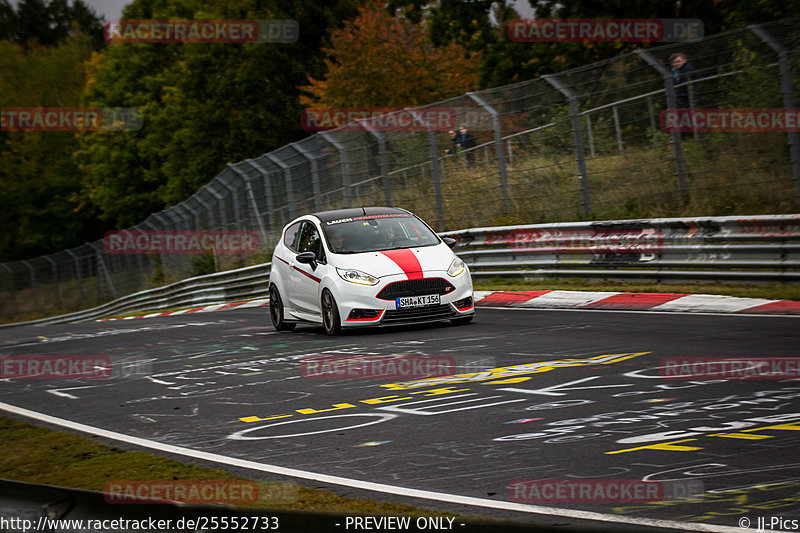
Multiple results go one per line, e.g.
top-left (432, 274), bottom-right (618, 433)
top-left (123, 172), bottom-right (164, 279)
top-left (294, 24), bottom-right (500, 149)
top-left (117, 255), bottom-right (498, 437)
top-left (300, 1), bottom-right (480, 107)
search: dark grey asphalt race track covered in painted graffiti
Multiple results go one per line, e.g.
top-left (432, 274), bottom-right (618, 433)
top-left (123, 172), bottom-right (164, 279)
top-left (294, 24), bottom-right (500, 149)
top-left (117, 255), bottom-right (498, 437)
top-left (0, 308), bottom-right (800, 531)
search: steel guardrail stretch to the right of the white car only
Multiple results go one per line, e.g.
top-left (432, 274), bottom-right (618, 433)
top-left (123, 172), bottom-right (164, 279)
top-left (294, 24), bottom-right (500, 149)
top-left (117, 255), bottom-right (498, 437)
top-left (447, 215), bottom-right (800, 282)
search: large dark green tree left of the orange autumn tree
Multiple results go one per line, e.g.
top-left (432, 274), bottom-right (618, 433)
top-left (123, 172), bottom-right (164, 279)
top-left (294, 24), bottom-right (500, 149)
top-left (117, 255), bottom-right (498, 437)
top-left (76, 0), bottom-right (356, 228)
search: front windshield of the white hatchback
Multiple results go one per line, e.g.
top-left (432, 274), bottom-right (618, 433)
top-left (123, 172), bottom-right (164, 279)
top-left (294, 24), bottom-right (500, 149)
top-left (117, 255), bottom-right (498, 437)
top-left (322, 214), bottom-right (440, 254)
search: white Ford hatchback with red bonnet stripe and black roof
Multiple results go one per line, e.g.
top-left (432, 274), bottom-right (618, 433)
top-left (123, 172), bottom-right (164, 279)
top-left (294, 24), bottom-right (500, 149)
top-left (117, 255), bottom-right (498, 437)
top-left (269, 207), bottom-right (475, 335)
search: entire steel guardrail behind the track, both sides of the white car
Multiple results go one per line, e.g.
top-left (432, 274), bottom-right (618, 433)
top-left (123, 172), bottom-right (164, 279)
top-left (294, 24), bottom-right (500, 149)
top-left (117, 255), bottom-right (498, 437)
top-left (0, 214), bottom-right (800, 327)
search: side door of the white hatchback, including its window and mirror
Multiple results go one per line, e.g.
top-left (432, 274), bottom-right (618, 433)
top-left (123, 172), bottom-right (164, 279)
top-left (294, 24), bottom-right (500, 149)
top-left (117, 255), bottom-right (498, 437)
top-left (291, 220), bottom-right (327, 317)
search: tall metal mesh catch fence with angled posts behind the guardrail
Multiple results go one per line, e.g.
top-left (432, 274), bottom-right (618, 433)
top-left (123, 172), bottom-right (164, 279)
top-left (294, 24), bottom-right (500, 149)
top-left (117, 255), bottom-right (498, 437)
top-left (0, 19), bottom-right (800, 321)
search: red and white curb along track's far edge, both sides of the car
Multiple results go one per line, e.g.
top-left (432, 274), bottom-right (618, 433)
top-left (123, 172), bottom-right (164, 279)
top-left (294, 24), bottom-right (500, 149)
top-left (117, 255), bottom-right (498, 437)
top-left (98, 290), bottom-right (800, 322)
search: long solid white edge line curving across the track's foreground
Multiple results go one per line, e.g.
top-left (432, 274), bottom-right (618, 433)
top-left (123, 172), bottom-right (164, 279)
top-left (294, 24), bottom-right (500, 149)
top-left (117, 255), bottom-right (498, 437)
top-left (0, 402), bottom-right (742, 533)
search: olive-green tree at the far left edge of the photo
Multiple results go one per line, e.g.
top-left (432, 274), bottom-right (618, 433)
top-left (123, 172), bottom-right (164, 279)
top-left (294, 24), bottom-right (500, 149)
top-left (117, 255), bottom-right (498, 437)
top-left (0, 36), bottom-right (103, 261)
